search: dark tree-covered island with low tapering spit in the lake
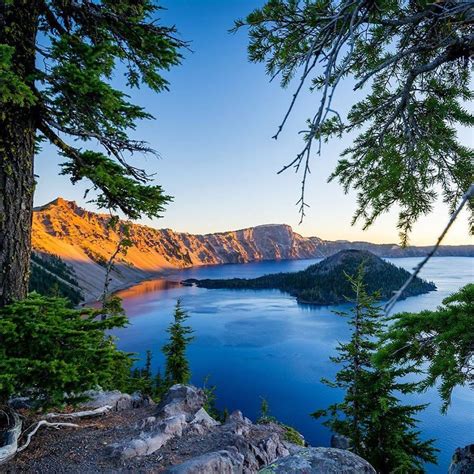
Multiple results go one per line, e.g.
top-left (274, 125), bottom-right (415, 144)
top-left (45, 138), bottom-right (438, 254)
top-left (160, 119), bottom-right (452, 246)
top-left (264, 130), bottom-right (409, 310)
top-left (183, 250), bottom-right (436, 305)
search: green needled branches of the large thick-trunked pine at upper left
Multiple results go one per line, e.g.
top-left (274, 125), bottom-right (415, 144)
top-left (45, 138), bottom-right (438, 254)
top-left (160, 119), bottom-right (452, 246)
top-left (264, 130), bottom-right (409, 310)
top-left (0, 0), bottom-right (186, 219)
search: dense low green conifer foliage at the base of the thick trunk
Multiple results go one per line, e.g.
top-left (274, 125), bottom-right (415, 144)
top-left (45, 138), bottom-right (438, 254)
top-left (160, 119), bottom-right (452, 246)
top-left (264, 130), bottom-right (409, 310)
top-left (0, 293), bottom-right (132, 406)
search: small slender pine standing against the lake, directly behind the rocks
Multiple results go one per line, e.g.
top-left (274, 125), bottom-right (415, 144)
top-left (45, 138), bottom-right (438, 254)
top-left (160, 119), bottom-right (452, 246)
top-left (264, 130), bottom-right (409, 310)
top-left (163, 300), bottom-right (194, 386)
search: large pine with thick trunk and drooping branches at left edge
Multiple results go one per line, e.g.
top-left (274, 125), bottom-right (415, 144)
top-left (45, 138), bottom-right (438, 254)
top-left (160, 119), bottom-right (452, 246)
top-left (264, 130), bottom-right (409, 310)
top-left (0, 0), bottom-right (185, 306)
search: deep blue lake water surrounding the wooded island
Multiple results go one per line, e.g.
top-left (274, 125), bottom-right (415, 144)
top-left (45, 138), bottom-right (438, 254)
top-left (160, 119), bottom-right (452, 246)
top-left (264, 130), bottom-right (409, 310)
top-left (114, 257), bottom-right (474, 473)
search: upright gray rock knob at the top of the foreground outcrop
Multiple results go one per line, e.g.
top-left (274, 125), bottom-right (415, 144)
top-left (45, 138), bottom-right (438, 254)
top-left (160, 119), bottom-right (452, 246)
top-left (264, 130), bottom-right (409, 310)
top-left (157, 384), bottom-right (206, 421)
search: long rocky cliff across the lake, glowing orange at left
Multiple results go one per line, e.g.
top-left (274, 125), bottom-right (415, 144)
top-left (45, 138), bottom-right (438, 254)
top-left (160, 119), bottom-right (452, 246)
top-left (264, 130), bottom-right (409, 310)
top-left (32, 198), bottom-right (474, 299)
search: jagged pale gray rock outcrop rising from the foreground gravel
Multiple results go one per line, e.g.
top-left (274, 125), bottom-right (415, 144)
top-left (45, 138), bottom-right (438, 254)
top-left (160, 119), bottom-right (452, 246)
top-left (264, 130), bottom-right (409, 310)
top-left (108, 385), bottom-right (290, 474)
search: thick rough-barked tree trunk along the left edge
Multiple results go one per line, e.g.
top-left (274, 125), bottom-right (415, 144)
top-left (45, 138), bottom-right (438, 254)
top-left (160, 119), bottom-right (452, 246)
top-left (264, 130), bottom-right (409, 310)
top-left (0, 0), bottom-right (38, 307)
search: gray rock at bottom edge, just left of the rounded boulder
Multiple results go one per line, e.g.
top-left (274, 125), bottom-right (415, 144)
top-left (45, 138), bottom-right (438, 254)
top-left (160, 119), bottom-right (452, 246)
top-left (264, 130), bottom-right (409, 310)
top-left (166, 447), bottom-right (244, 474)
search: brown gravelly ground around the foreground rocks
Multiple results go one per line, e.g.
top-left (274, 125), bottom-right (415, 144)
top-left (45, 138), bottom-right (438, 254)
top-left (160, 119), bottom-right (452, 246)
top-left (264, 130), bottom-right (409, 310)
top-left (0, 406), bottom-right (286, 474)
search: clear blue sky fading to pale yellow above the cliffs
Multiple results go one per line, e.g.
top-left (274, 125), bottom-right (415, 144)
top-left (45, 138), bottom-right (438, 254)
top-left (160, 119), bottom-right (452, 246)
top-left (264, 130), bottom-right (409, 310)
top-left (35, 0), bottom-right (474, 245)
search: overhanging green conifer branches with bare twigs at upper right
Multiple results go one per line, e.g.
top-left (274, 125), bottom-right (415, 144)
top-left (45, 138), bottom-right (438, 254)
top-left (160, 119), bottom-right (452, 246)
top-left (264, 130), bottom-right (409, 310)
top-left (236, 0), bottom-right (474, 244)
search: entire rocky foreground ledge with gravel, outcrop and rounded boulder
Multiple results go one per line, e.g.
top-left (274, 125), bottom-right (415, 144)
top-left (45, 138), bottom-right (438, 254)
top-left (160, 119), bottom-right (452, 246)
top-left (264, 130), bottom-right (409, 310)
top-left (0, 385), bottom-right (375, 474)
